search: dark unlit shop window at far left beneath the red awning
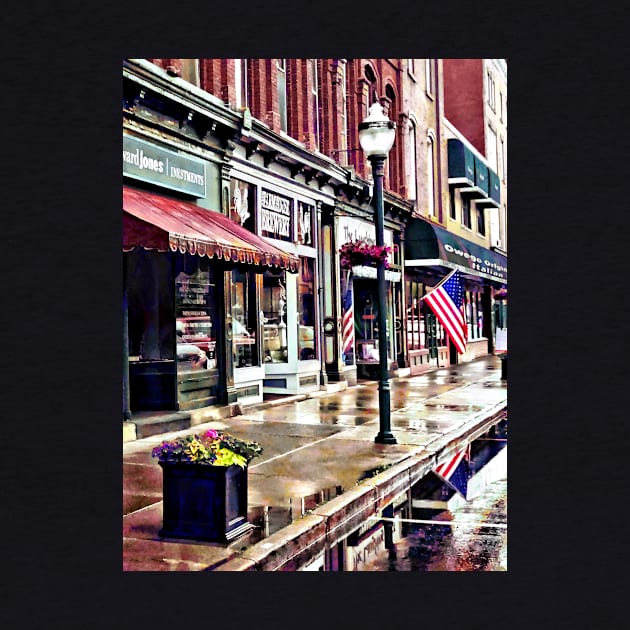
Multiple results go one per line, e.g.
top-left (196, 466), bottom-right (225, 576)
top-left (127, 249), bottom-right (175, 362)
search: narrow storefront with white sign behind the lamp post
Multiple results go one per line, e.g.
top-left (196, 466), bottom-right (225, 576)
top-left (337, 216), bottom-right (401, 378)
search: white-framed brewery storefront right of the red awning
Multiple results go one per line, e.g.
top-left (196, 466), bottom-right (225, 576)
top-left (230, 175), bottom-right (321, 399)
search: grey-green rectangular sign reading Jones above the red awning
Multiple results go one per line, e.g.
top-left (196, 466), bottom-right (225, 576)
top-left (123, 134), bottom-right (206, 197)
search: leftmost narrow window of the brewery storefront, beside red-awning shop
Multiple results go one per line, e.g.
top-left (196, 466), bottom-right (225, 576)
top-left (232, 269), bottom-right (260, 368)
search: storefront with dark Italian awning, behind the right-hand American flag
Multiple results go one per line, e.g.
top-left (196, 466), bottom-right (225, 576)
top-left (405, 218), bottom-right (507, 373)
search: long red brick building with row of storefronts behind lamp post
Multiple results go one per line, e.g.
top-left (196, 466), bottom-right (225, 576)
top-left (123, 59), bottom-right (508, 434)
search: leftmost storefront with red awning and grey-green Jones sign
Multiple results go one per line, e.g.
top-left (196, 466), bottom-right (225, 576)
top-left (122, 134), bottom-right (299, 418)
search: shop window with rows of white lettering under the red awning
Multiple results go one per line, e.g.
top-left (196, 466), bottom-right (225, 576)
top-left (175, 254), bottom-right (219, 373)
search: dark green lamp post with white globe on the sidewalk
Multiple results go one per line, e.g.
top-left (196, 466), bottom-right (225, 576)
top-left (359, 103), bottom-right (397, 444)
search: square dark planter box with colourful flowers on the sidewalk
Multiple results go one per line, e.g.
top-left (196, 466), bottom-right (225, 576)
top-left (152, 430), bottom-right (262, 543)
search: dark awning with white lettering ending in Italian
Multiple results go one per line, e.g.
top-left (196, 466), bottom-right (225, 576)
top-left (405, 219), bottom-right (507, 284)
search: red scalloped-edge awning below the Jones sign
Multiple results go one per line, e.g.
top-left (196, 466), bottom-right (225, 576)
top-left (123, 186), bottom-right (300, 273)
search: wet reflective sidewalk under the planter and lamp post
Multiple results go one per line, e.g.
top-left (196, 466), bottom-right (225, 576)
top-left (123, 356), bottom-right (507, 571)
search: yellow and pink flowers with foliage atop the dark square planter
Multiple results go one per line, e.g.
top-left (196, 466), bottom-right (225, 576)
top-left (151, 429), bottom-right (263, 468)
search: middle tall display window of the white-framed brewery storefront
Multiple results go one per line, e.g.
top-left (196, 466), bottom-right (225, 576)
top-left (263, 271), bottom-right (288, 363)
